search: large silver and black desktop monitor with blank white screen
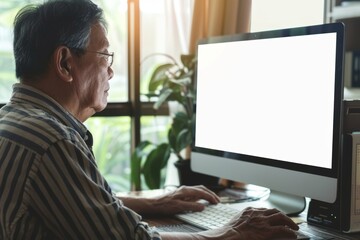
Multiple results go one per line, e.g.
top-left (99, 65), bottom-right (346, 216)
top-left (191, 23), bottom-right (344, 214)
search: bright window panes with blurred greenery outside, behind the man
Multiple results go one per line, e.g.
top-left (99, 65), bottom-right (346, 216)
top-left (0, 0), bottom-right (194, 191)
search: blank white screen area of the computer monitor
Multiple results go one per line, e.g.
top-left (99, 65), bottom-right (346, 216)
top-left (195, 33), bottom-right (336, 168)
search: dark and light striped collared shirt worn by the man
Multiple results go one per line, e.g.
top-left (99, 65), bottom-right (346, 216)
top-left (0, 84), bottom-right (160, 240)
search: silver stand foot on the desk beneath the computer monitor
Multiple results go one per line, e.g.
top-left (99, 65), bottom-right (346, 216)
top-left (229, 190), bottom-right (306, 216)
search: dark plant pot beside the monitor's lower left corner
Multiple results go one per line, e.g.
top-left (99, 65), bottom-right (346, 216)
top-left (174, 160), bottom-right (219, 188)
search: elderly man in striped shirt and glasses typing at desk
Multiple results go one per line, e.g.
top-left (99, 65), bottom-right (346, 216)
top-left (0, 0), bottom-right (298, 240)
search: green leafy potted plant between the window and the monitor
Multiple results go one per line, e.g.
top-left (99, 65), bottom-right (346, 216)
top-left (131, 54), bottom-right (218, 190)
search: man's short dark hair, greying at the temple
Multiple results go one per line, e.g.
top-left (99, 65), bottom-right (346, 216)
top-left (13, 0), bottom-right (106, 80)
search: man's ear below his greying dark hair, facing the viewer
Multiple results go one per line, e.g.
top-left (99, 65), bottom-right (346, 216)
top-left (53, 46), bottom-right (74, 82)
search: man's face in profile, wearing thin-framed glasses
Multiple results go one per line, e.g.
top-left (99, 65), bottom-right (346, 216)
top-left (74, 24), bottom-right (114, 115)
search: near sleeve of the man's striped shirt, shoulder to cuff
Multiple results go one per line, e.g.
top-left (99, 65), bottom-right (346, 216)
top-left (26, 140), bottom-right (161, 240)
